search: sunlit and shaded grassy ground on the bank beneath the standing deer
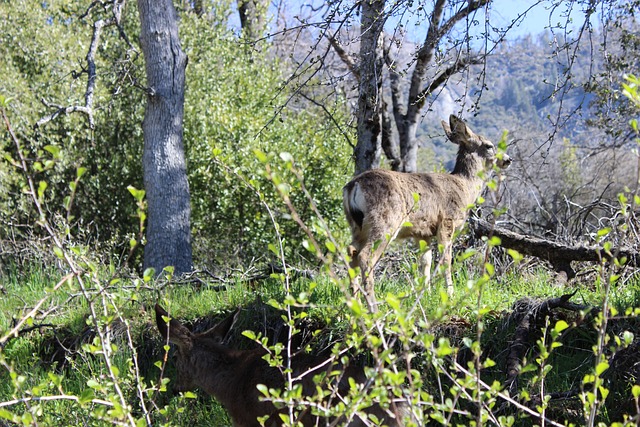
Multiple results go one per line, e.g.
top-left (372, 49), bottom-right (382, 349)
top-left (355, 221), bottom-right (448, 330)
top-left (0, 257), bottom-right (640, 426)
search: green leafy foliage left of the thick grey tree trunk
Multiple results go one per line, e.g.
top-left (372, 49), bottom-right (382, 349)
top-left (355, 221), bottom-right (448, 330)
top-left (0, 1), bottom-right (144, 247)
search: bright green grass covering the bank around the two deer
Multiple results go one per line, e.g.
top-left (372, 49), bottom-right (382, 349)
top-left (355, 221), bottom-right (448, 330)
top-left (0, 258), bottom-right (640, 426)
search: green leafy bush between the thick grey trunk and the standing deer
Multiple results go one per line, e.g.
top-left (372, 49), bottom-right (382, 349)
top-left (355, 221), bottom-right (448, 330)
top-left (181, 15), bottom-right (349, 262)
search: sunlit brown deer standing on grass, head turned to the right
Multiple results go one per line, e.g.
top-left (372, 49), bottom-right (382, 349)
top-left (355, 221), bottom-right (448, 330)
top-left (343, 115), bottom-right (511, 300)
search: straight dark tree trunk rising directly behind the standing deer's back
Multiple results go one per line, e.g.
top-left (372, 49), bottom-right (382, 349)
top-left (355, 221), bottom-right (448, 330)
top-left (354, 0), bottom-right (385, 175)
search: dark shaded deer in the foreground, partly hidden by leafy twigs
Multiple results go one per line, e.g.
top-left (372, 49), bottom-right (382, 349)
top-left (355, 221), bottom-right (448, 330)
top-left (155, 304), bottom-right (406, 427)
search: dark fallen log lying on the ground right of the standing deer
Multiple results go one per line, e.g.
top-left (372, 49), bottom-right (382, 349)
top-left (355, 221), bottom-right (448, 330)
top-left (469, 216), bottom-right (640, 279)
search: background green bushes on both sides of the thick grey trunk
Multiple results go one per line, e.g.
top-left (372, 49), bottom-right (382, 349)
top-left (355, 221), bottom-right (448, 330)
top-left (0, 2), bottom-right (349, 265)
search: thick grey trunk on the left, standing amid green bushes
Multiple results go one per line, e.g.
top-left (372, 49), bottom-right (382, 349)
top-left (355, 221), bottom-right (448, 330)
top-left (138, 0), bottom-right (193, 274)
